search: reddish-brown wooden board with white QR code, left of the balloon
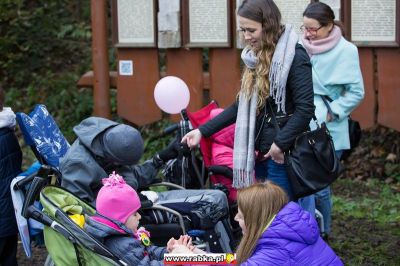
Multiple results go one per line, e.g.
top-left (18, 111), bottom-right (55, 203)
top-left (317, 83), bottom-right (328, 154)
top-left (117, 48), bottom-right (161, 126)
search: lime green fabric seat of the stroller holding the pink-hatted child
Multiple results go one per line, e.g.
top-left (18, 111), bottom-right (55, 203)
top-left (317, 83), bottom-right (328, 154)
top-left (40, 185), bottom-right (128, 265)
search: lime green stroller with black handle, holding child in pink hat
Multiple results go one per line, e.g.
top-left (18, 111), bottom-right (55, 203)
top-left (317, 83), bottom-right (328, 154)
top-left (14, 166), bottom-right (127, 265)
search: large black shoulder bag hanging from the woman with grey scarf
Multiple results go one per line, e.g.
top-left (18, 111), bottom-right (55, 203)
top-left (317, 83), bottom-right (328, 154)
top-left (268, 101), bottom-right (344, 198)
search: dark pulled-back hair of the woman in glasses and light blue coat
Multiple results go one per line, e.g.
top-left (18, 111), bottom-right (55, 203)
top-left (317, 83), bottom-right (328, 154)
top-left (303, 2), bottom-right (344, 35)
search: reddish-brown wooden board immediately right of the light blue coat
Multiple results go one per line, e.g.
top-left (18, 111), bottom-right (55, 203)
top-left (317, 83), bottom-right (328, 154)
top-left (351, 48), bottom-right (377, 128)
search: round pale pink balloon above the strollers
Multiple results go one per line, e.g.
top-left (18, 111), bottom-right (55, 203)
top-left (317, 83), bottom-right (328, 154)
top-left (154, 76), bottom-right (190, 114)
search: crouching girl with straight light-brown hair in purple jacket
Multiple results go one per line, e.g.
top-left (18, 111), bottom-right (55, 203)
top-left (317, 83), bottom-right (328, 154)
top-left (235, 181), bottom-right (343, 266)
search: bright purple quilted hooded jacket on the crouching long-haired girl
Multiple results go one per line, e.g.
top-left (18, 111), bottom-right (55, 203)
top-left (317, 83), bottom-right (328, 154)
top-left (242, 202), bottom-right (343, 266)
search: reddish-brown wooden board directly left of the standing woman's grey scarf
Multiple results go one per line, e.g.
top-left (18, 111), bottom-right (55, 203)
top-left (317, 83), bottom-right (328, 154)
top-left (209, 48), bottom-right (240, 108)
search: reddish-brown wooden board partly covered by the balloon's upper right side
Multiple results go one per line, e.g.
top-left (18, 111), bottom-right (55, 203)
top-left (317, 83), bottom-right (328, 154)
top-left (166, 48), bottom-right (204, 120)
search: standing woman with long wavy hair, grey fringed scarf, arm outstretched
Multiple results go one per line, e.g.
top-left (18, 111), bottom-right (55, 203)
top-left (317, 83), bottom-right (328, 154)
top-left (182, 0), bottom-right (314, 199)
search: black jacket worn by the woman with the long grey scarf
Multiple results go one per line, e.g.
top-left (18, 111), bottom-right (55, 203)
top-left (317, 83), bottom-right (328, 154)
top-left (199, 44), bottom-right (315, 153)
